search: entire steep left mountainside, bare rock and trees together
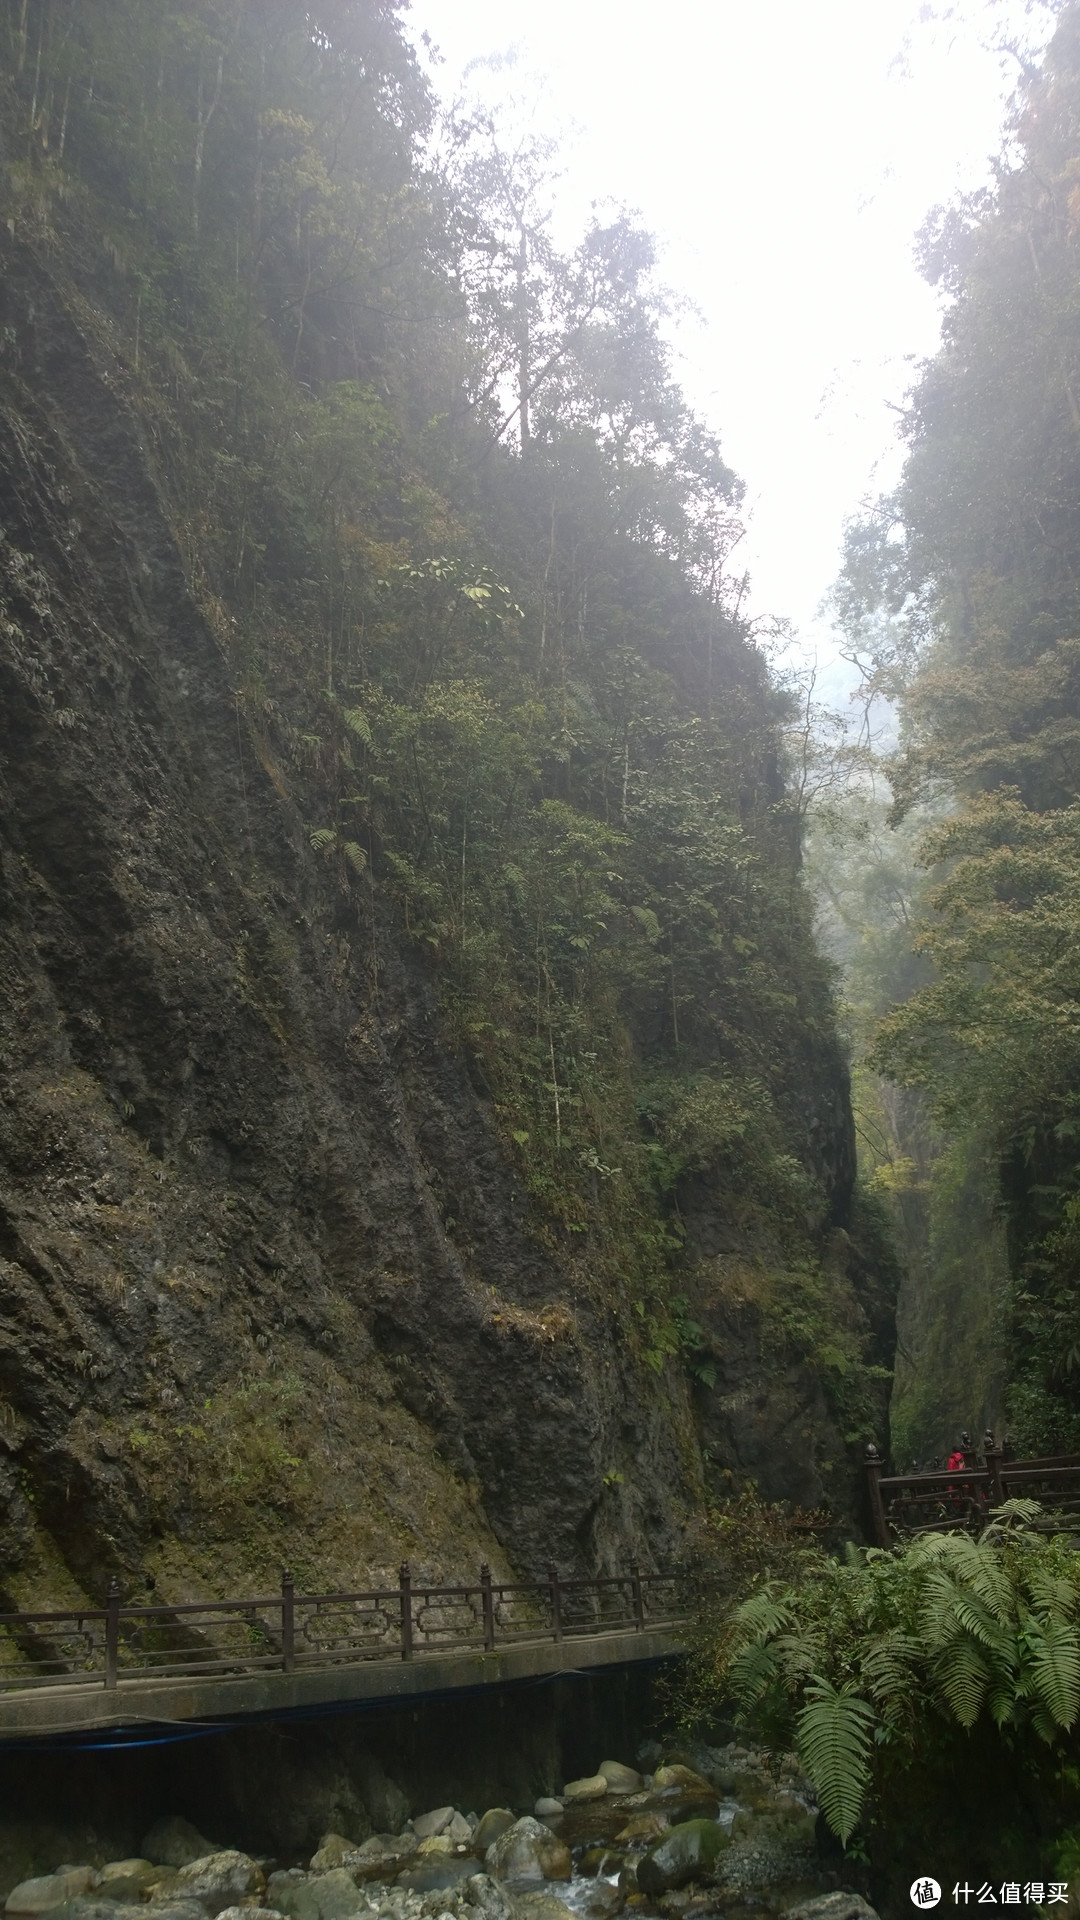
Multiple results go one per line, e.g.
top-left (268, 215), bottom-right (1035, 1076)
top-left (0, 6), bottom-right (892, 1603)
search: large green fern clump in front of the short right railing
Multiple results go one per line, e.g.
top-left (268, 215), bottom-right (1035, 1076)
top-left (694, 1501), bottom-right (1080, 1845)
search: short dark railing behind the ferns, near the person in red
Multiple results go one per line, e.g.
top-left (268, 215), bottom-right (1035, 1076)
top-left (867, 1430), bottom-right (1080, 1548)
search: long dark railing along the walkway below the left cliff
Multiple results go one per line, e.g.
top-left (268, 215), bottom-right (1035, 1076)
top-left (0, 1561), bottom-right (678, 1692)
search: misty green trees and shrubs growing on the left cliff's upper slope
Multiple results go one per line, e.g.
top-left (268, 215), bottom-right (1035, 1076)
top-left (0, 0), bottom-right (869, 1425)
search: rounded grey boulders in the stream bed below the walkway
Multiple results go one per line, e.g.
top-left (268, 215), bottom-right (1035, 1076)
top-left (6, 1745), bottom-right (876, 1920)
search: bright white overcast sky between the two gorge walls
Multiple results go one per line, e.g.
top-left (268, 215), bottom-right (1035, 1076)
top-left (405, 0), bottom-right (1049, 675)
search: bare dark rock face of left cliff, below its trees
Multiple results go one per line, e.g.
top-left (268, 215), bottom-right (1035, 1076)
top-left (0, 246), bottom-right (883, 1605)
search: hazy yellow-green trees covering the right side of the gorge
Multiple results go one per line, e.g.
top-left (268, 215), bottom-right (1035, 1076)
top-left (838, 4), bottom-right (1080, 1450)
